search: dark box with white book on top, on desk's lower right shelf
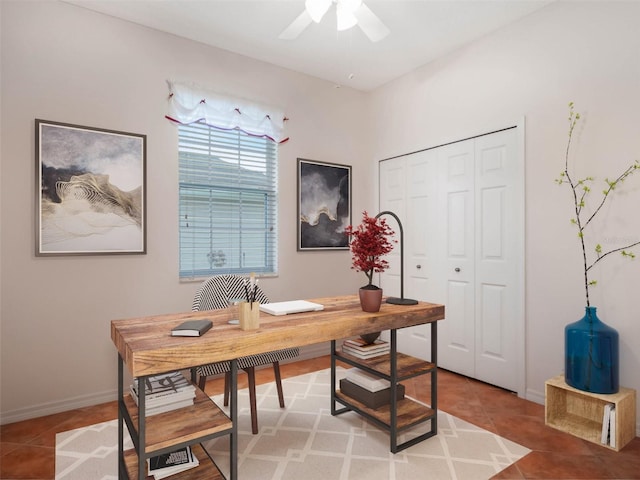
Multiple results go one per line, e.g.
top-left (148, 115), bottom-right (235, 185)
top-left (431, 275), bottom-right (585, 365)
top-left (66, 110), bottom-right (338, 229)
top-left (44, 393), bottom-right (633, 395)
top-left (340, 368), bottom-right (404, 409)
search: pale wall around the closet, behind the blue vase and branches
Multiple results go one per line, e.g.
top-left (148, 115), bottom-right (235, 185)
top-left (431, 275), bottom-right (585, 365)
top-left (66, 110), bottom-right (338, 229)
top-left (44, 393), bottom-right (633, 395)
top-left (371, 2), bottom-right (640, 430)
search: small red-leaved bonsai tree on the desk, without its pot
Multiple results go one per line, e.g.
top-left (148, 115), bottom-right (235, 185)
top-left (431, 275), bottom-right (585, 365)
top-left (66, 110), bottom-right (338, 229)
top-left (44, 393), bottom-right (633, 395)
top-left (345, 211), bottom-right (395, 290)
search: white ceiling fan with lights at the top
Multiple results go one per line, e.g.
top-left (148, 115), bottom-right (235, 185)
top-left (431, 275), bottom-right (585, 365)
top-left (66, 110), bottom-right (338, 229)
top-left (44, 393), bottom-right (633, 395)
top-left (278, 0), bottom-right (389, 42)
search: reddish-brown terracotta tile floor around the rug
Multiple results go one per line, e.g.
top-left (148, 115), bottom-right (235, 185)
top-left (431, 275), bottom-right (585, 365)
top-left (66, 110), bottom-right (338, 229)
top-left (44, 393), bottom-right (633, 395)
top-left (0, 356), bottom-right (640, 480)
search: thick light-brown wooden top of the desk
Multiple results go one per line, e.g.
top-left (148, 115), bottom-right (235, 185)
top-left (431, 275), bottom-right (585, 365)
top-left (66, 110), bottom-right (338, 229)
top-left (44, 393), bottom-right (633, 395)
top-left (111, 295), bottom-right (444, 377)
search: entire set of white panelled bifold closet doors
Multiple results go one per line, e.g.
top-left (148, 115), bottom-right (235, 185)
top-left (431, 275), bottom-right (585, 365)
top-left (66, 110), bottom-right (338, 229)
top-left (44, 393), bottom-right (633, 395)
top-left (380, 128), bottom-right (524, 394)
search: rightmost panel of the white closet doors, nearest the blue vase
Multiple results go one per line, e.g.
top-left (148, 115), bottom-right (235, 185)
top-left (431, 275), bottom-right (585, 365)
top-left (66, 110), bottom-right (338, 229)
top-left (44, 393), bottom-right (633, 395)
top-left (474, 129), bottom-right (524, 391)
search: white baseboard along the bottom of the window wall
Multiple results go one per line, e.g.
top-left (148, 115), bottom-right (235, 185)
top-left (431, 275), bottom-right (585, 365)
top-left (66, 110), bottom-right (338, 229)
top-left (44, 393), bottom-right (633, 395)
top-left (0, 342), bottom-right (331, 425)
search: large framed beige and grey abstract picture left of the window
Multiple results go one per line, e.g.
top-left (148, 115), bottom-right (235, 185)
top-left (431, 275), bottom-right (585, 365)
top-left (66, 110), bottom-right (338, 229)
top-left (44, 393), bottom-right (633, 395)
top-left (35, 119), bottom-right (147, 256)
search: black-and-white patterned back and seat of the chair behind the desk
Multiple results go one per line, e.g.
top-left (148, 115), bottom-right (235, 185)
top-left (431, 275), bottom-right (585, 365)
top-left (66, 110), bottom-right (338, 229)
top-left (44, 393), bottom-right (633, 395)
top-left (191, 275), bottom-right (300, 377)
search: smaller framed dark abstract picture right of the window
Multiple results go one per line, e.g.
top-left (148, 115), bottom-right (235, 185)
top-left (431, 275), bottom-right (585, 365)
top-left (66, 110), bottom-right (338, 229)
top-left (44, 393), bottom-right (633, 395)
top-left (297, 158), bottom-right (352, 251)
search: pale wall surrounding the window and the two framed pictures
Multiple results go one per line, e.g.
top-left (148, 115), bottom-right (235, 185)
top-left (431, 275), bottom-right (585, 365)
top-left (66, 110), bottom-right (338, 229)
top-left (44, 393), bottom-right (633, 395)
top-left (0, 1), bottom-right (375, 423)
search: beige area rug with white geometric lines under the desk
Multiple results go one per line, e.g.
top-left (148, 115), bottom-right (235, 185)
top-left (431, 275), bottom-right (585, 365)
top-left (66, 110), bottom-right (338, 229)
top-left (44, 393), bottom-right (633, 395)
top-left (56, 370), bottom-right (529, 480)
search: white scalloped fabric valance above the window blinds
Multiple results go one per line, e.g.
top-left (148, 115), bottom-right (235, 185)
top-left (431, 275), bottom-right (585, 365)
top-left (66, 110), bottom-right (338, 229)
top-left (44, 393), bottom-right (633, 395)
top-left (166, 81), bottom-right (289, 143)
